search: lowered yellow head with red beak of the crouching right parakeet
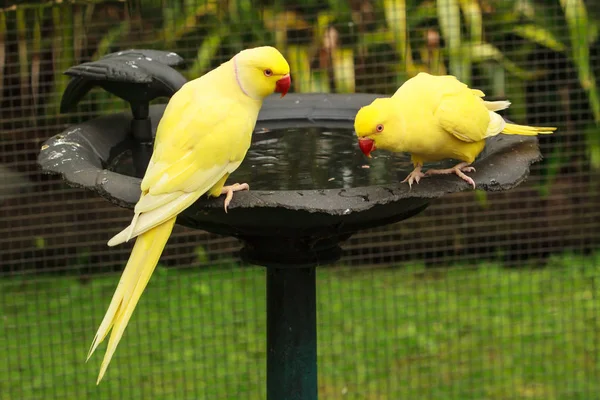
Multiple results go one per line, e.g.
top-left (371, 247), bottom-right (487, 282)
top-left (354, 98), bottom-right (397, 157)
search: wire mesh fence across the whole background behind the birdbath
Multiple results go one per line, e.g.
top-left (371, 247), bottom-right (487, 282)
top-left (0, 0), bottom-right (600, 400)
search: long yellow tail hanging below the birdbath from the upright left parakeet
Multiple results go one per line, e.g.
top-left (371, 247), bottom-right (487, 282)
top-left (88, 217), bottom-right (176, 384)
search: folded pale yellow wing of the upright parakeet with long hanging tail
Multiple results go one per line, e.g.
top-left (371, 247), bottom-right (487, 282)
top-left (108, 84), bottom-right (257, 246)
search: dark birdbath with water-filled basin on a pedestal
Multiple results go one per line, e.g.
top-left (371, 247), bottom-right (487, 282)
top-left (38, 50), bottom-right (540, 400)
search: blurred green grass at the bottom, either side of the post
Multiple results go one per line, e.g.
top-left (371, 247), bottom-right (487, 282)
top-left (0, 254), bottom-right (600, 400)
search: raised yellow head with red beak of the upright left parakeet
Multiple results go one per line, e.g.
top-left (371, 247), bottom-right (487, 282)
top-left (233, 46), bottom-right (292, 100)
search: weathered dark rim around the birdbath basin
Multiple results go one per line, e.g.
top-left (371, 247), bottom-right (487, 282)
top-left (38, 93), bottom-right (541, 215)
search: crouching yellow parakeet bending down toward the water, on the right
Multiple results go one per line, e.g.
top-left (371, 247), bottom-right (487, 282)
top-left (354, 72), bottom-right (556, 188)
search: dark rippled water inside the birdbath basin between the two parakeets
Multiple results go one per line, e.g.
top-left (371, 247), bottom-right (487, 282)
top-left (107, 128), bottom-right (452, 190)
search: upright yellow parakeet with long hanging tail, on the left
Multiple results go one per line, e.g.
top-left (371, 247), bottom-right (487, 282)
top-left (88, 47), bottom-right (291, 383)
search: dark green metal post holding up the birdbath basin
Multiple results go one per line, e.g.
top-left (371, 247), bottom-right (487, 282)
top-left (267, 267), bottom-right (318, 400)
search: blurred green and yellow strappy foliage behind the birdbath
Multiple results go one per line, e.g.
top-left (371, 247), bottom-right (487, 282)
top-left (0, 0), bottom-right (600, 178)
